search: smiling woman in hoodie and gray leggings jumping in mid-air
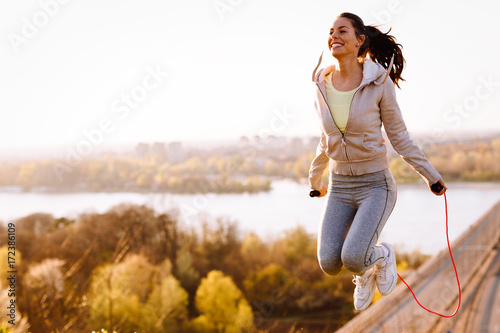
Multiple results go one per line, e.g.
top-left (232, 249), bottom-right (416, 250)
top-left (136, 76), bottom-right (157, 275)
top-left (309, 13), bottom-right (447, 310)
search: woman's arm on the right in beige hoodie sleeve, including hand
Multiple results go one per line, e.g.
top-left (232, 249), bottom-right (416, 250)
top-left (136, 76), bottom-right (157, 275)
top-left (379, 78), bottom-right (446, 195)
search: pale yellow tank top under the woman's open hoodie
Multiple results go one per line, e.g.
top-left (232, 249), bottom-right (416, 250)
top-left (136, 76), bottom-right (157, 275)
top-left (325, 72), bottom-right (358, 133)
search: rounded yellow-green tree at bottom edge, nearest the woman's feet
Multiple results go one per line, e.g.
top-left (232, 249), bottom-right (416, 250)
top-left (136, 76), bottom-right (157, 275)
top-left (193, 271), bottom-right (253, 333)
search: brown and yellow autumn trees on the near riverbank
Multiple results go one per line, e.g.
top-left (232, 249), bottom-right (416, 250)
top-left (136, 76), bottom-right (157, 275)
top-left (0, 204), bottom-right (426, 333)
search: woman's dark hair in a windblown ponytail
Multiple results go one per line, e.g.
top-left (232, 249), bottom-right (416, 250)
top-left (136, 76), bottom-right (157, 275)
top-left (338, 13), bottom-right (406, 88)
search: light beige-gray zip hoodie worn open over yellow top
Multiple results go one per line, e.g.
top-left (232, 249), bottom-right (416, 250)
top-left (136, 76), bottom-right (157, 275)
top-left (309, 59), bottom-right (441, 190)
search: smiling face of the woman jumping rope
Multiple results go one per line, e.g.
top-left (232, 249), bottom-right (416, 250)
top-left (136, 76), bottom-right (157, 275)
top-left (328, 17), bottom-right (365, 58)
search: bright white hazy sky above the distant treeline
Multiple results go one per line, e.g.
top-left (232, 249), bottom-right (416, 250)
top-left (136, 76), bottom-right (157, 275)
top-left (0, 0), bottom-right (500, 156)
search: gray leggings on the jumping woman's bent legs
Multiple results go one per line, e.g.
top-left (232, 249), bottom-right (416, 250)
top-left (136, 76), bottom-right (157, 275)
top-left (318, 169), bottom-right (397, 275)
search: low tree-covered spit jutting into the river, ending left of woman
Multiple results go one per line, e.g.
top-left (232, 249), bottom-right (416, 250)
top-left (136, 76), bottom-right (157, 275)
top-left (0, 154), bottom-right (271, 193)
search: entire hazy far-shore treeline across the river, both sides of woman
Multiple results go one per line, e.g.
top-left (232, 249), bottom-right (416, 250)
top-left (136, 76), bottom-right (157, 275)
top-left (0, 137), bottom-right (500, 193)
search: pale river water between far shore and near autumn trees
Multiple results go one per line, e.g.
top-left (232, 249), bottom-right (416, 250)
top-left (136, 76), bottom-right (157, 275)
top-left (0, 181), bottom-right (500, 254)
